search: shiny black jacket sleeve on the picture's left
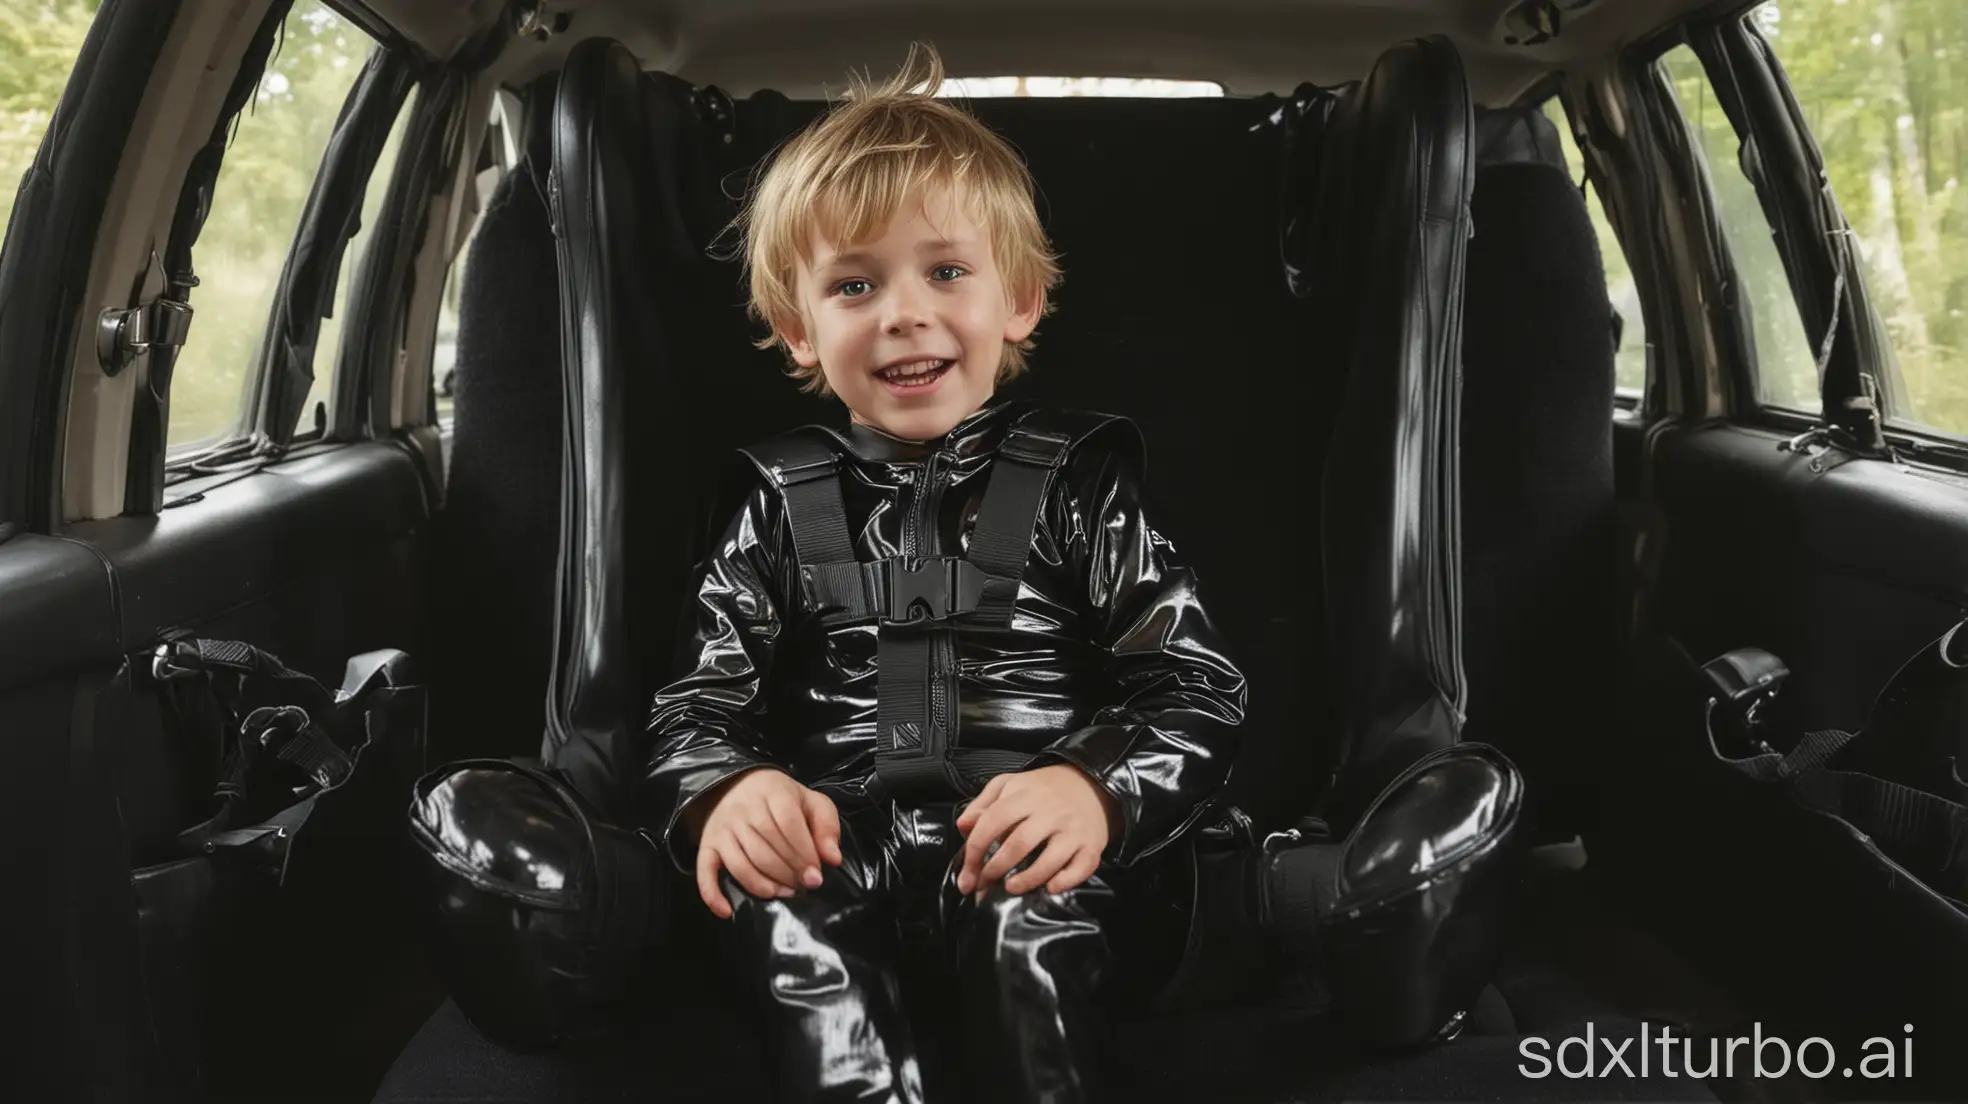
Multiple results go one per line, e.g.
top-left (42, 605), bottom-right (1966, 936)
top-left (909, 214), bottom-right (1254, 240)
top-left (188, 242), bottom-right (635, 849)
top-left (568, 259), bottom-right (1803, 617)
top-left (638, 484), bottom-right (783, 874)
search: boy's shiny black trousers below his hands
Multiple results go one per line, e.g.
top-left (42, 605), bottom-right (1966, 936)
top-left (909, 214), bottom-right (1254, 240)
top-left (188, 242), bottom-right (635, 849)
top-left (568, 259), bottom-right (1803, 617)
top-left (722, 805), bottom-right (1187, 1104)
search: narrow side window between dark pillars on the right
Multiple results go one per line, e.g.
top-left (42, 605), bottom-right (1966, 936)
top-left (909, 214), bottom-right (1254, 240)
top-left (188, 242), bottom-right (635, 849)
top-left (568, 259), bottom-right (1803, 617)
top-left (1659, 39), bottom-right (1820, 413)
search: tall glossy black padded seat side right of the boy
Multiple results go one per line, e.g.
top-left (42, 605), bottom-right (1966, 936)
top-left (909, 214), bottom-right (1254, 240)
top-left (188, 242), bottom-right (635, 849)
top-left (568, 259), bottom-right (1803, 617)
top-left (1295, 37), bottom-right (1474, 828)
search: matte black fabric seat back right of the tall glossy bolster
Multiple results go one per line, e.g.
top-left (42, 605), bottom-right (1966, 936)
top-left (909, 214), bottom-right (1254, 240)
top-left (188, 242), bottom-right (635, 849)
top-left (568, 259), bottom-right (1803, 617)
top-left (1462, 152), bottom-right (1620, 828)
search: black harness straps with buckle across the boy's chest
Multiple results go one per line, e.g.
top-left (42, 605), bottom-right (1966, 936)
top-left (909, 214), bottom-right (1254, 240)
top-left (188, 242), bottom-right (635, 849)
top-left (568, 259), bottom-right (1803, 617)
top-left (744, 409), bottom-right (1114, 797)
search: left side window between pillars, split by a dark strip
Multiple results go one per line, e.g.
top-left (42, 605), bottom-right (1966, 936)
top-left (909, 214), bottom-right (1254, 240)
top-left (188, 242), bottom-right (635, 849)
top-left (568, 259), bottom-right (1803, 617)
top-left (165, 0), bottom-right (409, 455)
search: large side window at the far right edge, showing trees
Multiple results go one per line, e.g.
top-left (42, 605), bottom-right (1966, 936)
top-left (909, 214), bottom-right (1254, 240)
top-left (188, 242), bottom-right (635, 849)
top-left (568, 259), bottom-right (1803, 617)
top-left (1750, 0), bottom-right (1968, 435)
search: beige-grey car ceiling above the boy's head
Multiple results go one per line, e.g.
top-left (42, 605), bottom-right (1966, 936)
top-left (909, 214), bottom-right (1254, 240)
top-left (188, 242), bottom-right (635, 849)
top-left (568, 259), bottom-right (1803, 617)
top-left (346, 0), bottom-right (1710, 104)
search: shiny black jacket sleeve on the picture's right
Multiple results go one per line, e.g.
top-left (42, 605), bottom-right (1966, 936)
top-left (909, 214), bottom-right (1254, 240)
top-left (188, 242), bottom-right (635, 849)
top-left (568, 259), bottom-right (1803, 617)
top-left (1041, 435), bottom-right (1246, 866)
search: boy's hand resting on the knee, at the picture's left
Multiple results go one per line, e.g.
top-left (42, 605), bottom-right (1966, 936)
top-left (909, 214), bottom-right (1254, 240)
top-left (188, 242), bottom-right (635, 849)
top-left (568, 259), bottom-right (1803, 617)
top-left (697, 767), bottom-right (840, 919)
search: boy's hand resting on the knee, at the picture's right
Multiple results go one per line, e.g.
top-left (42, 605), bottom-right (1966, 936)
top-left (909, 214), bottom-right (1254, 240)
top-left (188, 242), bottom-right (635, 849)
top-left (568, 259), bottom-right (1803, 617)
top-left (956, 764), bottom-right (1120, 893)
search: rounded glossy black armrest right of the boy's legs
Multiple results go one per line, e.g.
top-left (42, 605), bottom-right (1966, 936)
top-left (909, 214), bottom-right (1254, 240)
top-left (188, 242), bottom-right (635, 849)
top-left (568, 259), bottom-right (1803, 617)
top-left (1167, 744), bottom-right (1527, 1051)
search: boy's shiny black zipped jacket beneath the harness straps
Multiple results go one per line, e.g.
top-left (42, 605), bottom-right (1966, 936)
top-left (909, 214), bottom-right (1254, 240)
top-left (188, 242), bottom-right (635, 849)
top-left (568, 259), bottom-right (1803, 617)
top-left (642, 403), bottom-right (1246, 874)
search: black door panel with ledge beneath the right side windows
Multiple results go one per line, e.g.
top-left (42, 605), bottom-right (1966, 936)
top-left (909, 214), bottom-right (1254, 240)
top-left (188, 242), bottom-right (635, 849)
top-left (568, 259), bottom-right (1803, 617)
top-left (1622, 425), bottom-right (1968, 732)
